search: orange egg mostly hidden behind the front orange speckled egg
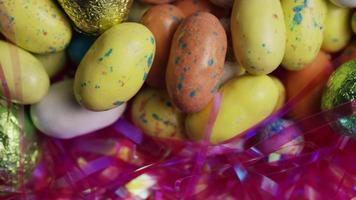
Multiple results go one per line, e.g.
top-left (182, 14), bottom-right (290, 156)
top-left (141, 4), bottom-right (184, 88)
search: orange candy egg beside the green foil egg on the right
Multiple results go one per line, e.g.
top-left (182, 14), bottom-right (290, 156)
top-left (285, 52), bottom-right (333, 119)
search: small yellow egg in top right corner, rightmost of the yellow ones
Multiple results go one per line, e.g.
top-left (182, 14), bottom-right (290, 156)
top-left (321, 2), bottom-right (352, 53)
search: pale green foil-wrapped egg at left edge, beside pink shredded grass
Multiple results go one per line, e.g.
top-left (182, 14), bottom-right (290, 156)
top-left (0, 101), bottom-right (39, 195)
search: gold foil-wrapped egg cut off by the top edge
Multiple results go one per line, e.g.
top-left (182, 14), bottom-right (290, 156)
top-left (58, 0), bottom-right (133, 35)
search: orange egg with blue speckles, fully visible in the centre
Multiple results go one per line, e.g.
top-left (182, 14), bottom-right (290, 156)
top-left (166, 12), bottom-right (227, 113)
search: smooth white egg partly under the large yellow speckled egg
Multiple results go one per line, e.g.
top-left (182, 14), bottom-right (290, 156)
top-left (31, 80), bottom-right (126, 139)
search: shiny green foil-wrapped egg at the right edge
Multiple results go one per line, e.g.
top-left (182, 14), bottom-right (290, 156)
top-left (321, 60), bottom-right (356, 136)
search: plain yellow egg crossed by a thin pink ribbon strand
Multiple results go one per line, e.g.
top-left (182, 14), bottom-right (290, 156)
top-left (185, 75), bottom-right (279, 144)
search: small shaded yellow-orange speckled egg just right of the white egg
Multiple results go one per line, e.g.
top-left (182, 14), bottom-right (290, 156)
top-left (131, 88), bottom-right (185, 139)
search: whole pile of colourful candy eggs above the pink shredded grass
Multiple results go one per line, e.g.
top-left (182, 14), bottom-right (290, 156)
top-left (0, 0), bottom-right (356, 185)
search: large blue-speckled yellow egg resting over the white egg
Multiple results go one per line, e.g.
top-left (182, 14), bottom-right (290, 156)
top-left (74, 22), bottom-right (156, 111)
